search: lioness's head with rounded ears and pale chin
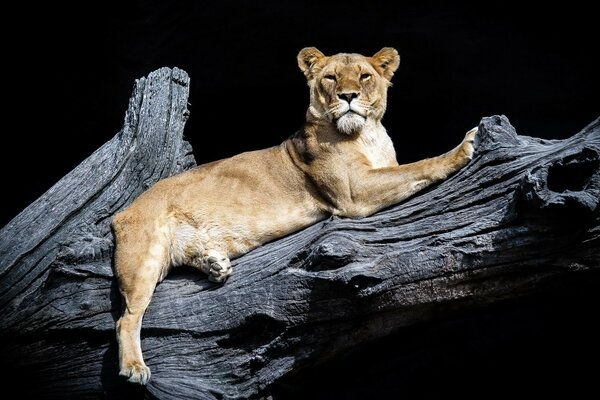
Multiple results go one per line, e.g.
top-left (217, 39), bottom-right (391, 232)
top-left (298, 47), bottom-right (400, 135)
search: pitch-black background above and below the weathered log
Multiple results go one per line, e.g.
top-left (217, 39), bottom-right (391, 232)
top-left (0, 0), bottom-right (600, 398)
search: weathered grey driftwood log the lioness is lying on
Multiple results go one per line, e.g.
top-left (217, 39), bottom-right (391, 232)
top-left (0, 68), bottom-right (600, 399)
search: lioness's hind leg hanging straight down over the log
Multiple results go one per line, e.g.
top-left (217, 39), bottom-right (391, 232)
top-left (115, 219), bottom-right (168, 385)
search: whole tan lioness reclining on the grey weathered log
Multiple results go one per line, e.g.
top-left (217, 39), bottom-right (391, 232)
top-left (112, 47), bottom-right (477, 384)
